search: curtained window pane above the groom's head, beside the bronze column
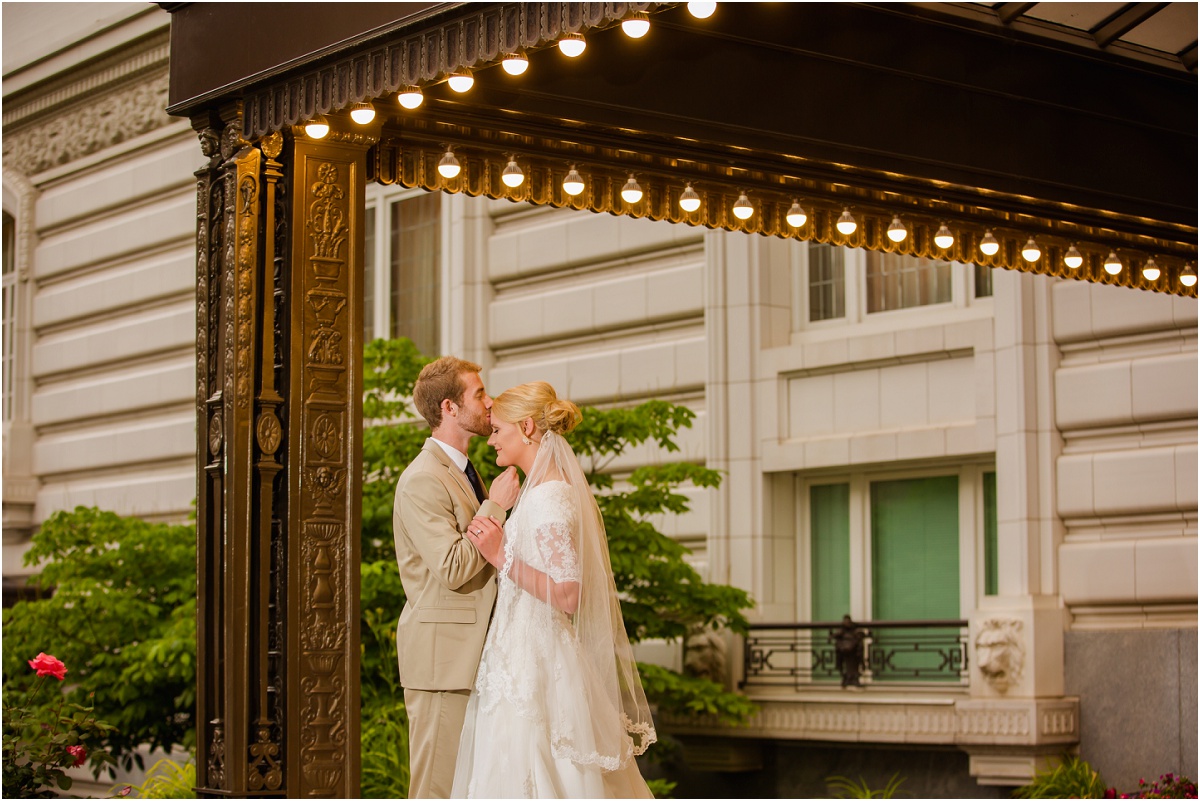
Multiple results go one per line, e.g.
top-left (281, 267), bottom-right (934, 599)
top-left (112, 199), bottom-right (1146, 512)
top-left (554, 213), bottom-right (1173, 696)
top-left (391, 192), bottom-right (442, 356)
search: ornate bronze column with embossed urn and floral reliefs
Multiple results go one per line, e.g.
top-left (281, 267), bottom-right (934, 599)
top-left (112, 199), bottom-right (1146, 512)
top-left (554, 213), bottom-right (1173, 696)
top-left (193, 106), bottom-right (371, 797)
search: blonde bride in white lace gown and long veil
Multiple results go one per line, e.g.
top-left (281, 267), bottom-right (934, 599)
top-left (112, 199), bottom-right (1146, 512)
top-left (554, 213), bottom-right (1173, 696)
top-left (451, 381), bottom-right (656, 799)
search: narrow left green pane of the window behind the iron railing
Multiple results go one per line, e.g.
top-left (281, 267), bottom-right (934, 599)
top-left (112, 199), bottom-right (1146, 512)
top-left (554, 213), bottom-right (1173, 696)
top-left (809, 484), bottom-right (850, 621)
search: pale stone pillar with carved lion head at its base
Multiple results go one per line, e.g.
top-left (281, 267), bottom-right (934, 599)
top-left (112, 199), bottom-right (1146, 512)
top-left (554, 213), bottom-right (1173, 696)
top-left (956, 271), bottom-right (1079, 784)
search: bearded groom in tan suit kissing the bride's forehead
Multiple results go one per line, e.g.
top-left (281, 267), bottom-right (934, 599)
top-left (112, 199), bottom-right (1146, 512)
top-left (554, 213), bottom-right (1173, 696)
top-left (391, 356), bottom-right (518, 799)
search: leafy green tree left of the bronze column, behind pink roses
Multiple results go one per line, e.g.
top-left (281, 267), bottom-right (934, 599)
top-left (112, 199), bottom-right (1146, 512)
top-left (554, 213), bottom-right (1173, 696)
top-left (4, 507), bottom-right (196, 766)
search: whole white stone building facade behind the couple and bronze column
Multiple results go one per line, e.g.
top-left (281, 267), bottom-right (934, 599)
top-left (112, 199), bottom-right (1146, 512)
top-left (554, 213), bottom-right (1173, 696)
top-left (4, 4), bottom-right (1198, 795)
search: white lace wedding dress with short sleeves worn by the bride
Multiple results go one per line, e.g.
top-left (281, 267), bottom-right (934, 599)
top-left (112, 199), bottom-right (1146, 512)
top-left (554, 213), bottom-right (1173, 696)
top-left (451, 481), bottom-right (652, 799)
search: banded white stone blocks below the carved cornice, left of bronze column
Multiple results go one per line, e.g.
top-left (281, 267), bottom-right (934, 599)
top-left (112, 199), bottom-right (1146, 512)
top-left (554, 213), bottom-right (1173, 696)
top-left (30, 122), bottom-right (203, 519)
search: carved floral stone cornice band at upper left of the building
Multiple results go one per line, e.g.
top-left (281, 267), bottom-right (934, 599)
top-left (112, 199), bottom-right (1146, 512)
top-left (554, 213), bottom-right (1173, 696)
top-left (4, 66), bottom-right (174, 175)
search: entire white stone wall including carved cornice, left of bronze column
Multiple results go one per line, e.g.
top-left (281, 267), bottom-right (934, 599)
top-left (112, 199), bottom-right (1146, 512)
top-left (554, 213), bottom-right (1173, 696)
top-left (4, 4), bottom-right (193, 578)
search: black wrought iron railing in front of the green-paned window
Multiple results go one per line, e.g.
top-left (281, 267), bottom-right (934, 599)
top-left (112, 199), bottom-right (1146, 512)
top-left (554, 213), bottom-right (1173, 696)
top-left (742, 615), bottom-right (968, 689)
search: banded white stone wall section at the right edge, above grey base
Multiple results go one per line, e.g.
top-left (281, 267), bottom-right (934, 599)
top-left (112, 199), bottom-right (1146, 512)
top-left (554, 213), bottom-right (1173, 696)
top-left (1054, 283), bottom-right (1196, 628)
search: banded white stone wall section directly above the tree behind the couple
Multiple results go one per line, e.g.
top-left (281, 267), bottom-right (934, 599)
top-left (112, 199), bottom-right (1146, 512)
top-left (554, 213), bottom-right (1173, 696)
top-left (480, 199), bottom-right (710, 553)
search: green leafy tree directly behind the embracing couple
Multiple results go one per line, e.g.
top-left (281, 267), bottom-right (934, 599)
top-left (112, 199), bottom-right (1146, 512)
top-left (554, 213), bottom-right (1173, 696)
top-left (352, 339), bottom-right (754, 797)
